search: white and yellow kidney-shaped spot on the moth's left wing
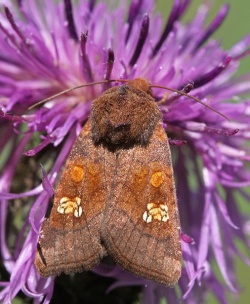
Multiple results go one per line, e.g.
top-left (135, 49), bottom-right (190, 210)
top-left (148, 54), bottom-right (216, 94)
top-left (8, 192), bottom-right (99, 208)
top-left (57, 196), bottom-right (82, 217)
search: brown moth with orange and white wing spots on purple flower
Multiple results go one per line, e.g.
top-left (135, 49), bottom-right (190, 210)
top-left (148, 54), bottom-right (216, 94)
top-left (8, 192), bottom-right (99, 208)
top-left (35, 78), bottom-right (182, 287)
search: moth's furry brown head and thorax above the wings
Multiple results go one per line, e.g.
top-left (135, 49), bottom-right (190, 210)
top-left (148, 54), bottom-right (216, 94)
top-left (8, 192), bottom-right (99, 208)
top-left (91, 78), bottom-right (162, 146)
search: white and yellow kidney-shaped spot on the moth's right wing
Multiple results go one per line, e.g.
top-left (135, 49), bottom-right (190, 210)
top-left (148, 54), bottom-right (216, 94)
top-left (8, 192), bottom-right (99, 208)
top-left (142, 203), bottom-right (169, 223)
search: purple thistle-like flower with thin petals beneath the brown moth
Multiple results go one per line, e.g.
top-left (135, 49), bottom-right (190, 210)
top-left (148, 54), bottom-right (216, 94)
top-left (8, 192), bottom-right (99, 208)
top-left (0, 0), bottom-right (250, 304)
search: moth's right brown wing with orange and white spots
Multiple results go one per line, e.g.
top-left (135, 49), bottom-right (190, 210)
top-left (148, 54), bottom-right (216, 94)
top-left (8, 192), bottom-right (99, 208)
top-left (101, 123), bottom-right (181, 286)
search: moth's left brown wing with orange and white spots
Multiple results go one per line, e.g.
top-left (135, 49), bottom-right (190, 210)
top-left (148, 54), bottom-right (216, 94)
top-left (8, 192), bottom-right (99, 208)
top-left (35, 122), bottom-right (108, 276)
